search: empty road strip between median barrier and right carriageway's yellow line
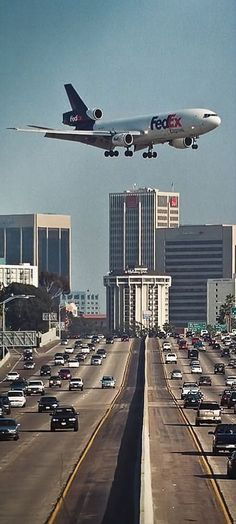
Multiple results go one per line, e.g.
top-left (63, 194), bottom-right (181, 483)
top-left (147, 339), bottom-right (226, 524)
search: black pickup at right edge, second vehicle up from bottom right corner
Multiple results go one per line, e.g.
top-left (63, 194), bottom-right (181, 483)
top-left (208, 424), bottom-right (236, 455)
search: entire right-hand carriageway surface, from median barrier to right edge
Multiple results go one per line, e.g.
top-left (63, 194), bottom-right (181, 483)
top-left (147, 339), bottom-right (236, 524)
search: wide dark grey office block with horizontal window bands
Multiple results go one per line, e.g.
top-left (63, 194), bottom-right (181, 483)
top-left (156, 225), bottom-right (236, 327)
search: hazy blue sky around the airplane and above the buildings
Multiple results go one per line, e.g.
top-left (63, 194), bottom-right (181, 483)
top-left (0, 0), bottom-right (236, 310)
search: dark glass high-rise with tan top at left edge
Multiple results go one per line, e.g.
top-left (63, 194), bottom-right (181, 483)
top-left (0, 213), bottom-right (71, 285)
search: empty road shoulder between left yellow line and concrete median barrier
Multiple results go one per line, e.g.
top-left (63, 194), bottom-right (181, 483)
top-left (50, 340), bottom-right (144, 524)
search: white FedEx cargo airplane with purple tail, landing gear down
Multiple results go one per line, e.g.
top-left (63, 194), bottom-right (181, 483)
top-left (10, 84), bottom-right (221, 158)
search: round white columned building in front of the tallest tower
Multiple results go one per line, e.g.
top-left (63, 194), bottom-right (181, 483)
top-left (104, 267), bottom-right (171, 332)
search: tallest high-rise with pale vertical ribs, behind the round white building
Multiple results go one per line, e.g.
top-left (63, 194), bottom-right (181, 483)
top-left (109, 188), bottom-right (179, 271)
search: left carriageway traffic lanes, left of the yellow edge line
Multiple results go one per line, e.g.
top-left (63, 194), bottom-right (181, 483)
top-left (0, 341), bottom-right (131, 524)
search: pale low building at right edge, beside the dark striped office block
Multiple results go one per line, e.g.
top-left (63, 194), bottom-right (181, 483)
top-left (207, 275), bottom-right (236, 326)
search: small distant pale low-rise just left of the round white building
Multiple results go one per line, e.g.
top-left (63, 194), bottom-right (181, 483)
top-left (61, 289), bottom-right (100, 315)
